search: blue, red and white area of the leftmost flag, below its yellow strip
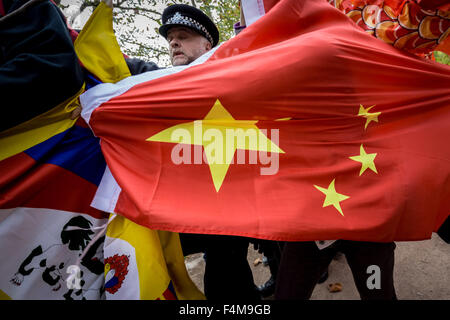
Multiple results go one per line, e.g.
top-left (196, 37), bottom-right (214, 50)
top-left (0, 120), bottom-right (108, 300)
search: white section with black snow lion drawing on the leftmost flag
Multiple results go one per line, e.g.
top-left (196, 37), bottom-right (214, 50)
top-left (0, 208), bottom-right (107, 300)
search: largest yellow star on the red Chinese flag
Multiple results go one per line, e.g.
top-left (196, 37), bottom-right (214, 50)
top-left (147, 99), bottom-right (284, 192)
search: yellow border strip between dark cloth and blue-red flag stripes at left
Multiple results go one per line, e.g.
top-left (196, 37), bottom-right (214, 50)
top-left (0, 86), bottom-right (84, 161)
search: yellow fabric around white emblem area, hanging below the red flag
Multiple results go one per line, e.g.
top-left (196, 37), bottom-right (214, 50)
top-left (105, 215), bottom-right (204, 300)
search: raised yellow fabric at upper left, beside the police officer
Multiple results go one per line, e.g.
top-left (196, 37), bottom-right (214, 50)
top-left (74, 2), bottom-right (131, 83)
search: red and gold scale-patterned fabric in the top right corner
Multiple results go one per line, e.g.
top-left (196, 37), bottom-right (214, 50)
top-left (329, 0), bottom-right (450, 55)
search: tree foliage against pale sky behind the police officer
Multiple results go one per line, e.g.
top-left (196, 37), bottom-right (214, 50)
top-left (56, 0), bottom-right (239, 66)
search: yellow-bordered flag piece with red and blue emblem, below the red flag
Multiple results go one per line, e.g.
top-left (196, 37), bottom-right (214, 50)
top-left (104, 215), bottom-right (205, 300)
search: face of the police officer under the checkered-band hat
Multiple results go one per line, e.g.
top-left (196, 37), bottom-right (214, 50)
top-left (167, 27), bottom-right (211, 66)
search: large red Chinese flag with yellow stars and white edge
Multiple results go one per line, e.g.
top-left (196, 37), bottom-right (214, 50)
top-left (82, 0), bottom-right (450, 241)
